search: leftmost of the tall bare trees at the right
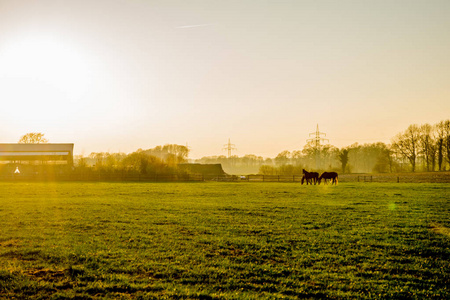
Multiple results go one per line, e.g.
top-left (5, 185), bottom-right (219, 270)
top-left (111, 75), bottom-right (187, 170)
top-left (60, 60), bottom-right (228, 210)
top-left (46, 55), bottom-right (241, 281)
top-left (392, 124), bottom-right (420, 172)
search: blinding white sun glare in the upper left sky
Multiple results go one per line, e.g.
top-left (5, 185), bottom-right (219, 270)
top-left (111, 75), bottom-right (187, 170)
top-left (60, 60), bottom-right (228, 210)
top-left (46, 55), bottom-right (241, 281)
top-left (0, 36), bottom-right (89, 117)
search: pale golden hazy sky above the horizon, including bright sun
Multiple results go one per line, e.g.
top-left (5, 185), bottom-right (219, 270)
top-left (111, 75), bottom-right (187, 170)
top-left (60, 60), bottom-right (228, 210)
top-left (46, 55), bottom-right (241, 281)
top-left (0, 0), bottom-right (450, 158)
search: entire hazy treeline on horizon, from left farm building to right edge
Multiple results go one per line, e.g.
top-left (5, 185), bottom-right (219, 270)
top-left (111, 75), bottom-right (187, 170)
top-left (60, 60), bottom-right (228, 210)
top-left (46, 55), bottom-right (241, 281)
top-left (75, 120), bottom-right (450, 175)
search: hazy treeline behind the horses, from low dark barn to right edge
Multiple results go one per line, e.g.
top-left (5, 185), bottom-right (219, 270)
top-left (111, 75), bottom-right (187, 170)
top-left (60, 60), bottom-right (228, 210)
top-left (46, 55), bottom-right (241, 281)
top-left (195, 120), bottom-right (450, 175)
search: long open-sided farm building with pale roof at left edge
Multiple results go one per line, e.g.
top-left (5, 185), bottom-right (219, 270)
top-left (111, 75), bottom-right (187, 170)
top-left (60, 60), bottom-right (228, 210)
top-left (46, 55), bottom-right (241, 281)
top-left (0, 144), bottom-right (73, 175)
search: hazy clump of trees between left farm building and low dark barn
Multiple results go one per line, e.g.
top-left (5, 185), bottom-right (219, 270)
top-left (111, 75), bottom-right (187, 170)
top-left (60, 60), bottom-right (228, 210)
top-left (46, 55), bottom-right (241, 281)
top-left (74, 144), bottom-right (189, 175)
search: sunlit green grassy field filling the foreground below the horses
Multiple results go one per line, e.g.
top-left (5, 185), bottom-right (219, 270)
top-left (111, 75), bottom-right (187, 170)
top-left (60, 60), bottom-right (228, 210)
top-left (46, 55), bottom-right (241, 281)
top-left (0, 182), bottom-right (450, 299)
